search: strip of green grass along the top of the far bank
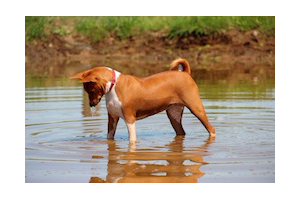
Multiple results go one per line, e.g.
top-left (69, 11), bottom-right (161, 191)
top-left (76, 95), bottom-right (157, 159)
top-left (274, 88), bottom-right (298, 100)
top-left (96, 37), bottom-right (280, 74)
top-left (25, 16), bottom-right (275, 43)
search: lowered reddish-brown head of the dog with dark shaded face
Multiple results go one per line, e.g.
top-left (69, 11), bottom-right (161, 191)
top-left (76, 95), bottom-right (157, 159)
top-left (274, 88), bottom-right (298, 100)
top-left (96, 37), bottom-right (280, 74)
top-left (70, 67), bottom-right (111, 107)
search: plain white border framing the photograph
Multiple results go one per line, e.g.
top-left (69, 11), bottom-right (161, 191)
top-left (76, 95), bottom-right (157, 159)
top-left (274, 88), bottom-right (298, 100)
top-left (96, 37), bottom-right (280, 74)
top-left (1, 0), bottom-right (300, 200)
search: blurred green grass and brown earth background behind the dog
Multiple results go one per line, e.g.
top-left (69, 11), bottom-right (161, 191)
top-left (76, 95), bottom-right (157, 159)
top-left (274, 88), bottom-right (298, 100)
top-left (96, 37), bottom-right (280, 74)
top-left (25, 16), bottom-right (275, 87)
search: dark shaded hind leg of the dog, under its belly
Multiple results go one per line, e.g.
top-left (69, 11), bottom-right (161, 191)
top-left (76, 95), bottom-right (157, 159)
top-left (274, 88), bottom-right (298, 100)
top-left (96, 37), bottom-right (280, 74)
top-left (167, 104), bottom-right (185, 135)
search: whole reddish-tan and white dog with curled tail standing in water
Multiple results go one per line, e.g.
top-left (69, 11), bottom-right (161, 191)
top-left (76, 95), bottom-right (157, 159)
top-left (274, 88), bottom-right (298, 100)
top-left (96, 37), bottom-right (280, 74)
top-left (71, 58), bottom-right (215, 141)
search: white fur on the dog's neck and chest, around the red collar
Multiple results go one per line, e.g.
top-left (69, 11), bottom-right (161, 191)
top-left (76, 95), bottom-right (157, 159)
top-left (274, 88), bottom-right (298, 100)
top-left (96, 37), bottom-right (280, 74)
top-left (105, 71), bottom-right (124, 119)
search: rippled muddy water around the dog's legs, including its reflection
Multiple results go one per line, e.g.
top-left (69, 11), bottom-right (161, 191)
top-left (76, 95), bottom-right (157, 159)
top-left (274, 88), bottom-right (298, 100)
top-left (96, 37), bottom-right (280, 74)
top-left (25, 66), bottom-right (275, 183)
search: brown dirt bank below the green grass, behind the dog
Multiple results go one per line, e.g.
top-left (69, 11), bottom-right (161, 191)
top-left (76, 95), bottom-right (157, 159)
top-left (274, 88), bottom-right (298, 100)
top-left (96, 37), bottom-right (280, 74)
top-left (25, 30), bottom-right (275, 78)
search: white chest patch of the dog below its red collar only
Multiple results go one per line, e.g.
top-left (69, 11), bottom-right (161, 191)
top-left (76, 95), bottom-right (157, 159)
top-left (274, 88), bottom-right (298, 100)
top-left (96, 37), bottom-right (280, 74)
top-left (105, 88), bottom-right (123, 118)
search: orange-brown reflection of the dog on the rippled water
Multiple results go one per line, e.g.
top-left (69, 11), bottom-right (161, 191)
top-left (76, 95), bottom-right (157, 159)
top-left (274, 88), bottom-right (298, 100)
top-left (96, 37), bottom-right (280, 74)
top-left (90, 136), bottom-right (215, 183)
